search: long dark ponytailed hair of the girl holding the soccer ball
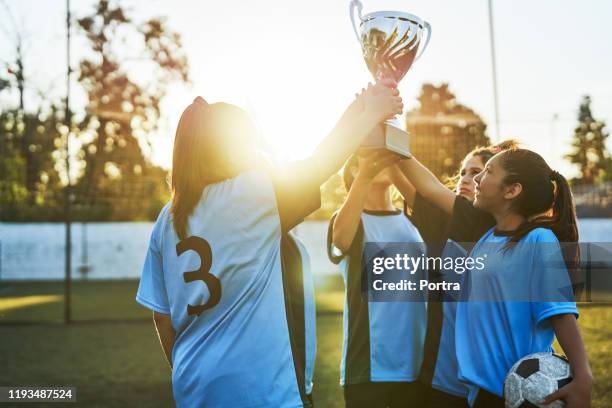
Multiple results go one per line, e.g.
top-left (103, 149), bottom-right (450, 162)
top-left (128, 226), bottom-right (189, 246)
top-left (499, 149), bottom-right (578, 262)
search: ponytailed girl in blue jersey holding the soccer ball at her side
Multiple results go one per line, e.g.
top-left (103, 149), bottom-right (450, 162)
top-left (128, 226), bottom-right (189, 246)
top-left (455, 149), bottom-right (592, 408)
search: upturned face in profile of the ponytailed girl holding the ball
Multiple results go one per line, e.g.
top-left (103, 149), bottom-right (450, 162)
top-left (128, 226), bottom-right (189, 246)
top-left (474, 154), bottom-right (520, 212)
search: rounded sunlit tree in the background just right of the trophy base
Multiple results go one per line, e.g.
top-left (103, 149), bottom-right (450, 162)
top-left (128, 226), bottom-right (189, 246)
top-left (406, 84), bottom-right (490, 179)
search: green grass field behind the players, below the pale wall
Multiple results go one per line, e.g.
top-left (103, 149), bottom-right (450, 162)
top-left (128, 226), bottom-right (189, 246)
top-left (0, 281), bottom-right (612, 408)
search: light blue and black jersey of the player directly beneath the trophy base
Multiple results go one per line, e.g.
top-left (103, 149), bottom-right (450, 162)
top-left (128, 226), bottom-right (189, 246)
top-left (328, 210), bottom-right (427, 385)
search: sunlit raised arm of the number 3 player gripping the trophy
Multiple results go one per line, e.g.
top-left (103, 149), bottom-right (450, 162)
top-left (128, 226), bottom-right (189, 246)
top-left (306, 80), bottom-right (403, 185)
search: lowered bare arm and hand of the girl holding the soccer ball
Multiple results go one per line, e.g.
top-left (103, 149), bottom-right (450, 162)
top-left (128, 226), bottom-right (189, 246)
top-left (544, 314), bottom-right (593, 408)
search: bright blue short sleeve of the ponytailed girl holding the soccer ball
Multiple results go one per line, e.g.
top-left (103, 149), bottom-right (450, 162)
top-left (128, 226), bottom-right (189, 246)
top-left (531, 231), bottom-right (578, 324)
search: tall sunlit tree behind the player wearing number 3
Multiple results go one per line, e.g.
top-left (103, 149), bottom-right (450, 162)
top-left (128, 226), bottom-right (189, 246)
top-left (75, 0), bottom-right (189, 219)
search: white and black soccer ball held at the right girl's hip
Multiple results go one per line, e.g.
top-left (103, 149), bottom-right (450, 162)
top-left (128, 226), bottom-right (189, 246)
top-left (504, 353), bottom-right (572, 408)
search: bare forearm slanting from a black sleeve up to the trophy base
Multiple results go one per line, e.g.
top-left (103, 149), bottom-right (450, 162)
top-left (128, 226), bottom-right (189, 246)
top-left (398, 157), bottom-right (456, 214)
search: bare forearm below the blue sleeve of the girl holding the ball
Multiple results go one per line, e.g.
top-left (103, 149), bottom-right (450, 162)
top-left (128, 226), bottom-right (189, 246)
top-left (550, 314), bottom-right (592, 379)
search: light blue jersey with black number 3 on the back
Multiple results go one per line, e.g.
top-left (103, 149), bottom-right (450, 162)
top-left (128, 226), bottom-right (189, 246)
top-left (136, 170), bottom-right (320, 407)
